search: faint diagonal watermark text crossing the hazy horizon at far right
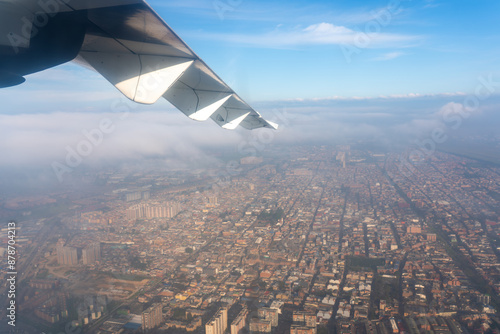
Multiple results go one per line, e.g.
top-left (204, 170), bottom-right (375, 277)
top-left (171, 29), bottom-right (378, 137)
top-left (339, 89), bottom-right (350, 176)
top-left (398, 74), bottom-right (500, 176)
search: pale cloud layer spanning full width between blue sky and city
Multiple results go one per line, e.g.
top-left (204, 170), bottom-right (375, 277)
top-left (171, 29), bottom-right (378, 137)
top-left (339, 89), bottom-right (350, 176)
top-left (0, 95), bottom-right (500, 174)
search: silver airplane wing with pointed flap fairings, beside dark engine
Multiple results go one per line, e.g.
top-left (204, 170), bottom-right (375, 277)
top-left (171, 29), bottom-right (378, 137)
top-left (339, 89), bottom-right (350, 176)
top-left (73, 0), bottom-right (278, 130)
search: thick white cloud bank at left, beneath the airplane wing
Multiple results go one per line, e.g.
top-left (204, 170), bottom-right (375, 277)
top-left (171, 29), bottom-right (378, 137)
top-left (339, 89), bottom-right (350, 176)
top-left (0, 111), bottom-right (241, 167)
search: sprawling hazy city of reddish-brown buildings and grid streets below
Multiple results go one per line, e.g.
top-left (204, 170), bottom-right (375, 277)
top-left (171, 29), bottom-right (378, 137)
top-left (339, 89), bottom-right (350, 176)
top-left (0, 144), bottom-right (500, 334)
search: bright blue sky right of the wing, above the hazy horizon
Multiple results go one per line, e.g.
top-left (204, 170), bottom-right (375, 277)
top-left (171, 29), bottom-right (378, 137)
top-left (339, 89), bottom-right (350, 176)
top-left (146, 0), bottom-right (500, 100)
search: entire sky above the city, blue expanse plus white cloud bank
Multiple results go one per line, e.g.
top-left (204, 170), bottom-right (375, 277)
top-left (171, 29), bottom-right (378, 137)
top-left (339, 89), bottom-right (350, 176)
top-left (0, 0), bottom-right (500, 183)
